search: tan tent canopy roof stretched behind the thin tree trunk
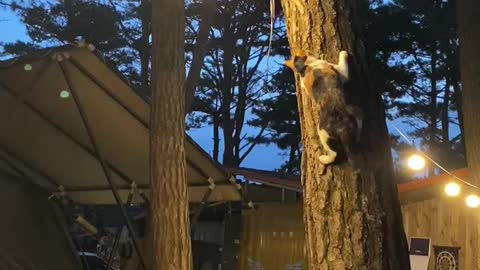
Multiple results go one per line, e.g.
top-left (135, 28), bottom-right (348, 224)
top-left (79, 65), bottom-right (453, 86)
top-left (0, 45), bottom-right (241, 204)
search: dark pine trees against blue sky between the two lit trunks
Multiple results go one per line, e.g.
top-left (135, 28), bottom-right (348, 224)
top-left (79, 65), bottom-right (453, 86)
top-left (187, 0), bottom-right (280, 167)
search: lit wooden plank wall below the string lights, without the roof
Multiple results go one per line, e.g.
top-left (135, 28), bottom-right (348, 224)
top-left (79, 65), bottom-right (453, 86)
top-left (402, 196), bottom-right (480, 270)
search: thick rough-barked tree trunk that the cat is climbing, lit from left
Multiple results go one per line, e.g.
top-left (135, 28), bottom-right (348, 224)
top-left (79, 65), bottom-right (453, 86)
top-left (281, 0), bottom-right (410, 270)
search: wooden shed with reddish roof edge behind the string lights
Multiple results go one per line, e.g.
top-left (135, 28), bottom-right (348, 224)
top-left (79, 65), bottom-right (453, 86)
top-left (398, 169), bottom-right (480, 270)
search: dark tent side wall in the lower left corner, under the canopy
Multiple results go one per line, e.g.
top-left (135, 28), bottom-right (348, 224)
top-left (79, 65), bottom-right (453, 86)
top-left (0, 171), bottom-right (82, 270)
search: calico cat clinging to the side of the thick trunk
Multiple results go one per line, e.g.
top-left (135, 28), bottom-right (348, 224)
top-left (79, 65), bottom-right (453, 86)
top-left (285, 51), bottom-right (363, 165)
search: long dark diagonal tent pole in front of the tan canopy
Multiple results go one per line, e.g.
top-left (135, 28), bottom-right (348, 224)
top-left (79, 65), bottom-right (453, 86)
top-left (58, 61), bottom-right (147, 270)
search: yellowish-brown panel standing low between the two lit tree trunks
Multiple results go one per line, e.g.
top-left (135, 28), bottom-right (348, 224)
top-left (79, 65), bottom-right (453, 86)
top-left (239, 203), bottom-right (305, 270)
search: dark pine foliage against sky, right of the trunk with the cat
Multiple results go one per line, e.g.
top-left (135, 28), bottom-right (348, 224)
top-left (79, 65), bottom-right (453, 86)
top-left (367, 0), bottom-right (464, 173)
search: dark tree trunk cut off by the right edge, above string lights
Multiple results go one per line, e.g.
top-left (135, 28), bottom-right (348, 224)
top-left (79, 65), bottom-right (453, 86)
top-left (457, 0), bottom-right (480, 185)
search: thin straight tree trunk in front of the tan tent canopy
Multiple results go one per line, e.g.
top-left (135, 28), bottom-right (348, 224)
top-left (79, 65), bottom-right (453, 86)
top-left (150, 0), bottom-right (191, 270)
